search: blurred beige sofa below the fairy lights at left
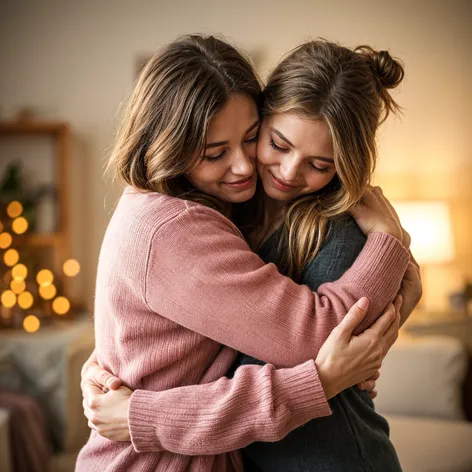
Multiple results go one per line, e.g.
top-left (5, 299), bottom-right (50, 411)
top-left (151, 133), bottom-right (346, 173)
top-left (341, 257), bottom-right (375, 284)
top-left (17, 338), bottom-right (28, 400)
top-left (0, 318), bottom-right (94, 472)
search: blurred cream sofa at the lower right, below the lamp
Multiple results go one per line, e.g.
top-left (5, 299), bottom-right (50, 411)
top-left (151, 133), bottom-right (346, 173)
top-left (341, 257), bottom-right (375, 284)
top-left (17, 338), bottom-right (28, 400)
top-left (375, 335), bottom-right (472, 472)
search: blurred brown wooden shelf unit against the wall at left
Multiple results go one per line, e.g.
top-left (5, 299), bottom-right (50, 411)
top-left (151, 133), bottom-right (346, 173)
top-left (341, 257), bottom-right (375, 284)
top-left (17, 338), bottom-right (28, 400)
top-left (0, 120), bottom-right (71, 297)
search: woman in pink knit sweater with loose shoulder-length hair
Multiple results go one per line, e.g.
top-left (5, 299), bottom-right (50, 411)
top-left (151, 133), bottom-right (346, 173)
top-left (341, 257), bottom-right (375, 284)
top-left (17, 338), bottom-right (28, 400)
top-left (77, 37), bottom-right (409, 471)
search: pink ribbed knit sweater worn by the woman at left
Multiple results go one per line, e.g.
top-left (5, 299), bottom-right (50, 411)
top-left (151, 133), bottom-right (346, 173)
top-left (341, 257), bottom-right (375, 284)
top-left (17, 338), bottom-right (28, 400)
top-left (76, 190), bottom-right (409, 472)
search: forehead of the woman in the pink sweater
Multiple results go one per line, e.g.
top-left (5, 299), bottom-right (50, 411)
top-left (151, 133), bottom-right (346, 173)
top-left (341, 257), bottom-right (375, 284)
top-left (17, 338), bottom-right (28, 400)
top-left (208, 95), bottom-right (259, 141)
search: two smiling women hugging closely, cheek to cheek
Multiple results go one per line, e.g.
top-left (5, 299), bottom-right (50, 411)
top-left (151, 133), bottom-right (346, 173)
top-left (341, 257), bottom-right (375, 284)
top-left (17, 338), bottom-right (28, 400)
top-left (76, 35), bottom-right (421, 472)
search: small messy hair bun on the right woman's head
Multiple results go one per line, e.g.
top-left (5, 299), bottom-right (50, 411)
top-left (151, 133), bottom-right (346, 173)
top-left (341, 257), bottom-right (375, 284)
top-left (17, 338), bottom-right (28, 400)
top-left (355, 46), bottom-right (405, 89)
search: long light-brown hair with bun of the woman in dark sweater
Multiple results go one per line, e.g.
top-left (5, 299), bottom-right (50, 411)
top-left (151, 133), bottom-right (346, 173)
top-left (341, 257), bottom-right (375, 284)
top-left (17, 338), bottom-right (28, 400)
top-left (256, 40), bottom-right (404, 278)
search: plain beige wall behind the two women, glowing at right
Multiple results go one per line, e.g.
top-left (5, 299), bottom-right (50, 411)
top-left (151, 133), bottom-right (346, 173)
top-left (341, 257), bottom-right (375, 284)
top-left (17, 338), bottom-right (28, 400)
top-left (0, 0), bottom-right (472, 312)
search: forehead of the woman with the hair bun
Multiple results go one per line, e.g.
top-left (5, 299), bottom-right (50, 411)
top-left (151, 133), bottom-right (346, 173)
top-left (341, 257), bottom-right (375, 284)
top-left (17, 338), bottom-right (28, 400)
top-left (267, 113), bottom-right (333, 157)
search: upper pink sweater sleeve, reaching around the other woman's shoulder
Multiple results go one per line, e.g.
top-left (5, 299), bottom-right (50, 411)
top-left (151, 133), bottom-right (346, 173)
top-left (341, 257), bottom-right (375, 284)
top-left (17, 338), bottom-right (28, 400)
top-left (144, 206), bottom-right (409, 367)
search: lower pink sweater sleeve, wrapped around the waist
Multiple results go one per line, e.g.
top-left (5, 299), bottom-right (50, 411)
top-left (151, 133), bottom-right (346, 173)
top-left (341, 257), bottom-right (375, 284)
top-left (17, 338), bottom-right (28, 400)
top-left (129, 360), bottom-right (330, 455)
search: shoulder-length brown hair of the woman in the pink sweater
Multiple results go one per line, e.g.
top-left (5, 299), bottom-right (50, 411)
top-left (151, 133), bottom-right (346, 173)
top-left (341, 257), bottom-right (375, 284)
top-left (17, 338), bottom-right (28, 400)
top-left (107, 35), bottom-right (262, 213)
